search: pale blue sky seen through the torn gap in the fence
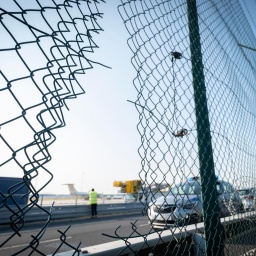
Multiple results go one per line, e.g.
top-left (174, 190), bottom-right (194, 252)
top-left (0, 0), bottom-right (256, 194)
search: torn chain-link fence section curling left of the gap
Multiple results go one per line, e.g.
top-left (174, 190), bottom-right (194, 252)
top-left (0, 0), bottom-right (104, 255)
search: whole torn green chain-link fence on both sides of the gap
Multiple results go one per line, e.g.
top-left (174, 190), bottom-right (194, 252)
top-left (0, 0), bottom-right (256, 255)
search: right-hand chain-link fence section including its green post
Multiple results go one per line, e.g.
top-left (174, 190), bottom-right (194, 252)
top-left (102, 0), bottom-right (256, 255)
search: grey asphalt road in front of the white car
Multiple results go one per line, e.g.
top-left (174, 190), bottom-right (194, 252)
top-left (0, 214), bottom-right (150, 256)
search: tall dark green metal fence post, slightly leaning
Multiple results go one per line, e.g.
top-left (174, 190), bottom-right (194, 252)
top-left (187, 0), bottom-right (224, 256)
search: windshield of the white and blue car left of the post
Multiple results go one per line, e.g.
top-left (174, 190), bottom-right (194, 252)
top-left (171, 181), bottom-right (201, 195)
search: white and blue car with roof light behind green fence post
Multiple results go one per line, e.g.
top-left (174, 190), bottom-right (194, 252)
top-left (148, 177), bottom-right (244, 227)
